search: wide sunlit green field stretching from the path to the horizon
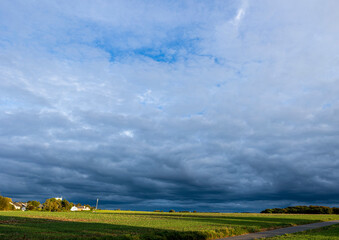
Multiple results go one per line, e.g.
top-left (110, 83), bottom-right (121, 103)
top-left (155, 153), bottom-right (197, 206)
top-left (0, 211), bottom-right (339, 240)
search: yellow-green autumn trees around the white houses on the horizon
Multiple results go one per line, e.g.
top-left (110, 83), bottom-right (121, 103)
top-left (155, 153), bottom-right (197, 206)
top-left (0, 196), bottom-right (92, 212)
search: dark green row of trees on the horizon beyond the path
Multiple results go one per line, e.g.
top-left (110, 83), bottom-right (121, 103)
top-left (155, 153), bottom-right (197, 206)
top-left (261, 205), bottom-right (339, 214)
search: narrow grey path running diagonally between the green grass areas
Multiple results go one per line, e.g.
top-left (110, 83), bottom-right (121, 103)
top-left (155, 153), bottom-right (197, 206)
top-left (217, 220), bottom-right (339, 240)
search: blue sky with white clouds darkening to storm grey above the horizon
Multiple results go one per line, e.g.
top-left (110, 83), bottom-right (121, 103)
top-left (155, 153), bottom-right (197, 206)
top-left (0, 0), bottom-right (339, 212)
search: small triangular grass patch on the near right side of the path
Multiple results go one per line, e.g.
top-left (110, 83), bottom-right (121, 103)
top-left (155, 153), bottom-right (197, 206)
top-left (266, 224), bottom-right (339, 240)
